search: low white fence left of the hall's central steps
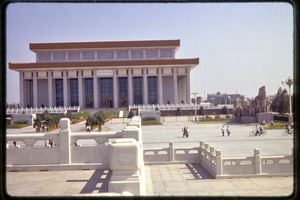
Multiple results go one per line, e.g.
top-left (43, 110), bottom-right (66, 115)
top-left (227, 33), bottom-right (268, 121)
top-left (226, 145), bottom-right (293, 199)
top-left (6, 106), bottom-right (80, 114)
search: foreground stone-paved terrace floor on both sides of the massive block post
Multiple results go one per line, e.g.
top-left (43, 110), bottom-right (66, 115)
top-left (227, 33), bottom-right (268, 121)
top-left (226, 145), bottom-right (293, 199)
top-left (6, 164), bottom-right (293, 197)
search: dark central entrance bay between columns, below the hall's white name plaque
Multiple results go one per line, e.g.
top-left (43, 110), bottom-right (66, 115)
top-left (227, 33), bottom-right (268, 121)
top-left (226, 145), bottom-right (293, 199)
top-left (100, 78), bottom-right (113, 108)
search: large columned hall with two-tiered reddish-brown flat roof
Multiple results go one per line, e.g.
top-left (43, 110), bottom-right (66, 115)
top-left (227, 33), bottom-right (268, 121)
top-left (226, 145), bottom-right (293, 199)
top-left (9, 40), bottom-right (199, 108)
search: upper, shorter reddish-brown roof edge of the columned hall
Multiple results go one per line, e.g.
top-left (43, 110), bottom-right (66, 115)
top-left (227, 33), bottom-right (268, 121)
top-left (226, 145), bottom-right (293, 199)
top-left (29, 40), bottom-right (180, 52)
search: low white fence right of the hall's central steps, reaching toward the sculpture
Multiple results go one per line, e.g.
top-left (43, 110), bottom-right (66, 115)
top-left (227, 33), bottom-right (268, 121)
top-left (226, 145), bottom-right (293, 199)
top-left (129, 103), bottom-right (233, 111)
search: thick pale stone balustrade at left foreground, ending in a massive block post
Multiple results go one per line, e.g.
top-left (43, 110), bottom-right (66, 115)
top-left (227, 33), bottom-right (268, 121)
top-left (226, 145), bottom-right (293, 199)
top-left (6, 117), bottom-right (145, 195)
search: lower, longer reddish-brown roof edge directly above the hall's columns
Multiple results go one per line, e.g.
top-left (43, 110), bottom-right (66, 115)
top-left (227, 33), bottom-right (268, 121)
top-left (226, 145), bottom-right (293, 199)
top-left (9, 58), bottom-right (199, 71)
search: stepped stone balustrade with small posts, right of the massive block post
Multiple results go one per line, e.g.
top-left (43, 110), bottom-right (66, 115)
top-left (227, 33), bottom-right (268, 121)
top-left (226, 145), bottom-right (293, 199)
top-left (144, 141), bottom-right (293, 178)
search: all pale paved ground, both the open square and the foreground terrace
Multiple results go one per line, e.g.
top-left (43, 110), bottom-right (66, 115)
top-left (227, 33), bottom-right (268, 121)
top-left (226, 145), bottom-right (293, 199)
top-left (6, 119), bottom-right (294, 197)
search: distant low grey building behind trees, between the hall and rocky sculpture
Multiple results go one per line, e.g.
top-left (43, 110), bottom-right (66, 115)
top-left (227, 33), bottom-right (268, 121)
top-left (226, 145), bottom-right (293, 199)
top-left (207, 92), bottom-right (247, 105)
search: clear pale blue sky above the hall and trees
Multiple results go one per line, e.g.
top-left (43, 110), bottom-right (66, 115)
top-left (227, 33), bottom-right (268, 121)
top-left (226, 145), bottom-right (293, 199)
top-left (6, 2), bottom-right (294, 103)
